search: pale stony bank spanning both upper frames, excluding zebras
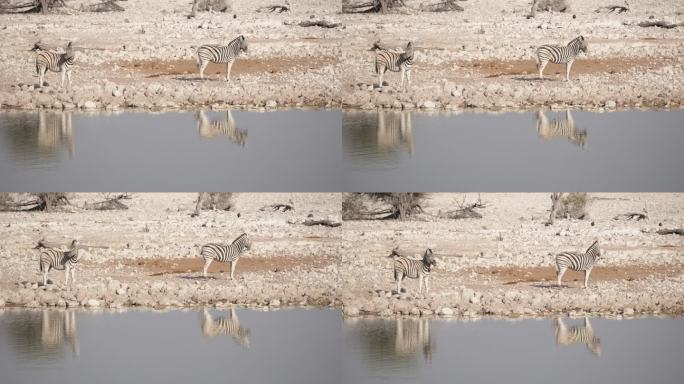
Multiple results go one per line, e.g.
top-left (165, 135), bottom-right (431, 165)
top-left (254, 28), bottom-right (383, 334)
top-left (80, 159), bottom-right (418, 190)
top-left (0, 0), bottom-right (684, 109)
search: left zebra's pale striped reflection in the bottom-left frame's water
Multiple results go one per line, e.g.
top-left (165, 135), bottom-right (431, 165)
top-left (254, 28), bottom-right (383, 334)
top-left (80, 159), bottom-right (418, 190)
top-left (40, 309), bottom-right (79, 356)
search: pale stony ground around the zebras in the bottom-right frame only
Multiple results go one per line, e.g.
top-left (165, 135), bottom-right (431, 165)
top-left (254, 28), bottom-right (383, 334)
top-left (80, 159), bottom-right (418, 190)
top-left (339, 193), bottom-right (684, 316)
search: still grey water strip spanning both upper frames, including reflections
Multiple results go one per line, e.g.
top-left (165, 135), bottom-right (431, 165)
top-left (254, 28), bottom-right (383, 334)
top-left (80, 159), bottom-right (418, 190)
top-left (0, 110), bottom-right (684, 192)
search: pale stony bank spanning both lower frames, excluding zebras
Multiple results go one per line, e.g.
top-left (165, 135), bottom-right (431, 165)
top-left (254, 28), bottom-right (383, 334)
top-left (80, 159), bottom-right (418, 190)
top-left (0, 193), bottom-right (684, 316)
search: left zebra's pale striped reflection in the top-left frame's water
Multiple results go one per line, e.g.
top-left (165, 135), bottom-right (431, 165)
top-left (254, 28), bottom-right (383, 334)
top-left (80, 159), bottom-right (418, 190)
top-left (38, 111), bottom-right (75, 157)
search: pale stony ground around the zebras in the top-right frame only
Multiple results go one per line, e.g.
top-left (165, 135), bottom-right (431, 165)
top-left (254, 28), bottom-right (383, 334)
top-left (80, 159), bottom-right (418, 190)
top-left (340, 0), bottom-right (684, 109)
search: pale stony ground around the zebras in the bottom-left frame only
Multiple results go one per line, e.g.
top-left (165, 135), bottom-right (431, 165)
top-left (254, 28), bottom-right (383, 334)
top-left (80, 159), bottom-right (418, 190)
top-left (0, 193), bottom-right (341, 307)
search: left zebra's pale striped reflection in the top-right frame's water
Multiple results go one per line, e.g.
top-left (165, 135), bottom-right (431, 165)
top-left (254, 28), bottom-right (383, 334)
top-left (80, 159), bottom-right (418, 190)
top-left (377, 112), bottom-right (414, 155)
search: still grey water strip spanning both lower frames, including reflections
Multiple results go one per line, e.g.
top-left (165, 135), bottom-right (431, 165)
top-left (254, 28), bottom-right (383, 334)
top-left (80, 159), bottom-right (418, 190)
top-left (0, 309), bottom-right (684, 384)
